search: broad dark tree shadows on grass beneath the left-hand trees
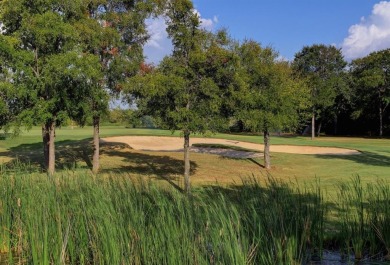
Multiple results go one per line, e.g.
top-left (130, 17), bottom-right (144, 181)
top-left (0, 139), bottom-right (193, 191)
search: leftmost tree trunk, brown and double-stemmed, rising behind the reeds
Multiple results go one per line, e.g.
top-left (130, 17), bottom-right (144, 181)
top-left (42, 120), bottom-right (56, 176)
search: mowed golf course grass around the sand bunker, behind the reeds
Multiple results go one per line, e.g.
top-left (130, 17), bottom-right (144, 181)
top-left (0, 126), bottom-right (390, 189)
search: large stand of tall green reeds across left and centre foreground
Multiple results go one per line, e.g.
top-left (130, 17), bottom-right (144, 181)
top-left (0, 168), bottom-right (324, 264)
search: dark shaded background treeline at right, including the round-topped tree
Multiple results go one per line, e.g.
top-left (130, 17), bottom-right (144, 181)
top-left (292, 45), bottom-right (390, 137)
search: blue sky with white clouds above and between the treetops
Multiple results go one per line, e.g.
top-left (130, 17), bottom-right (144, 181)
top-left (145, 0), bottom-right (390, 63)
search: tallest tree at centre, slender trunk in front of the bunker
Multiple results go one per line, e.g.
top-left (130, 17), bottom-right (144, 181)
top-left (128, 0), bottom-right (236, 193)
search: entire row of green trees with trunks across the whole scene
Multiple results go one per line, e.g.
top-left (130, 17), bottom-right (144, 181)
top-left (0, 0), bottom-right (390, 191)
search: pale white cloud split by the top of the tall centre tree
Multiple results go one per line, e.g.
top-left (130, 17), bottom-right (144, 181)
top-left (144, 9), bottom-right (218, 64)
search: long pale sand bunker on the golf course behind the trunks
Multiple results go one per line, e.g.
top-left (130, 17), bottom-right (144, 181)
top-left (101, 136), bottom-right (360, 158)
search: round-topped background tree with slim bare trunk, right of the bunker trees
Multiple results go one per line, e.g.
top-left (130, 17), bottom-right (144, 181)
top-left (292, 44), bottom-right (347, 139)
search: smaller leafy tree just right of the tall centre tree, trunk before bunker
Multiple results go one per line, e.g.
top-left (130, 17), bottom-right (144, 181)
top-left (236, 41), bottom-right (307, 169)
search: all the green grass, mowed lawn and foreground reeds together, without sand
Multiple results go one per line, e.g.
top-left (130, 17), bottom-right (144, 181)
top-left (0, 127), bottom-right (390, 264)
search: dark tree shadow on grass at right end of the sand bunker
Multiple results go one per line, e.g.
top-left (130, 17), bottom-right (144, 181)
top-left (315, 151), bottom-right (390, 167)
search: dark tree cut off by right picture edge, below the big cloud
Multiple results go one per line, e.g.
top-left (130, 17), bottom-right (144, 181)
top-left (351, 49), bottom-right (390, 137)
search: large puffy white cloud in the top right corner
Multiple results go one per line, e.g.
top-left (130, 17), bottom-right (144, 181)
top-left (342, 1), bottom-right (390, 59)
